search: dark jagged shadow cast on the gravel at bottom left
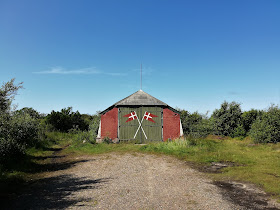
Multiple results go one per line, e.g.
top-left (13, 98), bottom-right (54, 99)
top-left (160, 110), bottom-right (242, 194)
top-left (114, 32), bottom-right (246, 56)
top-left (1, 175), bottom-right (110, 209)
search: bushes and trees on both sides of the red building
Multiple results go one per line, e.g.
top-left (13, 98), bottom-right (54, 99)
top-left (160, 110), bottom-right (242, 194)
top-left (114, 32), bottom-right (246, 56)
top-left (0, 79), bottom-right (280, 169)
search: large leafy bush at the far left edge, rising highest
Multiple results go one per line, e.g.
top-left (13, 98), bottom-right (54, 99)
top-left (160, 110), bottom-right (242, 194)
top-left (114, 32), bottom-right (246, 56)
top-left (0, 79), bottom-right (39, 164)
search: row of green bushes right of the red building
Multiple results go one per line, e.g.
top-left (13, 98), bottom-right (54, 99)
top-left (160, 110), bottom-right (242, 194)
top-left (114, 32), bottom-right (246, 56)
top-left (180, 101), bottom-right (280, 143)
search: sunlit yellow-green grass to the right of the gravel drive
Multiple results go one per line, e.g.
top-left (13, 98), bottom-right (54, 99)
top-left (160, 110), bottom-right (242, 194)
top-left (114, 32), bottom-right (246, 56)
top-left (138, 139), bottom-right (280, 199)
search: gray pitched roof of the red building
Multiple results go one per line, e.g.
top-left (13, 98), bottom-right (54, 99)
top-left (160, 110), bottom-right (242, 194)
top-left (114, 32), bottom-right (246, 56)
top-left (101, 90), bottom-right (178, 114)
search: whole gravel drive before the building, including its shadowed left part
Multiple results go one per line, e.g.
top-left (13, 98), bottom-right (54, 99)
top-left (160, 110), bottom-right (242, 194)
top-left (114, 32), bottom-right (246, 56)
top-left (4, 153), bottom-right (276, 209)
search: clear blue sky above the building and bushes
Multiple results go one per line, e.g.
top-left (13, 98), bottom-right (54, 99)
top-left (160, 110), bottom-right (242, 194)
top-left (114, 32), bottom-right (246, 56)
top-left (0, 0), bottom-right (280, 114)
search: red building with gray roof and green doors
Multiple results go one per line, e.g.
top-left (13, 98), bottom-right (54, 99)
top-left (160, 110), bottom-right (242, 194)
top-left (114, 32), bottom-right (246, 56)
top-left (97, 90), bottom-right (183, 143)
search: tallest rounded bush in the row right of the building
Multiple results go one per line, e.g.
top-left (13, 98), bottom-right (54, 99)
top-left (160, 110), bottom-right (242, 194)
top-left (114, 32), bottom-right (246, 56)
top-left (211, 101), bottom-right (242, 137)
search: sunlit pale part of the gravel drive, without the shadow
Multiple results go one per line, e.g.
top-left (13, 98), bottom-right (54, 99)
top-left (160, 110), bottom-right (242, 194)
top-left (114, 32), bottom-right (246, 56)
top-left (71, 154), bottom-right (236, 209)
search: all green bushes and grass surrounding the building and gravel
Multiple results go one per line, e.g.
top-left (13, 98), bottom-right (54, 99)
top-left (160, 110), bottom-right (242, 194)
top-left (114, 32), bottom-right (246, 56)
top-left (0, 79), bottom-right (280, 202)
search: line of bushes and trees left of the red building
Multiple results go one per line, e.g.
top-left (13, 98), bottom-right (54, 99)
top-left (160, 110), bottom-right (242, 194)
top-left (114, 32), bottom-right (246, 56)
top-left (0, 79), bottom-right (99, 168)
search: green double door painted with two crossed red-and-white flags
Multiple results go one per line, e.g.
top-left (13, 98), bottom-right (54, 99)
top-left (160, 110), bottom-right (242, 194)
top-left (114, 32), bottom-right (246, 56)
top-left (118, 107), bottom-right (162, 143)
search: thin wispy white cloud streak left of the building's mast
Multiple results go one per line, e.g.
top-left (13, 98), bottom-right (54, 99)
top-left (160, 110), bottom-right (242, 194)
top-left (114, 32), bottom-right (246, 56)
top-left (33, 67), bottom-right (126, 76)
